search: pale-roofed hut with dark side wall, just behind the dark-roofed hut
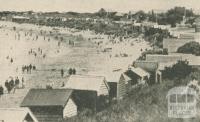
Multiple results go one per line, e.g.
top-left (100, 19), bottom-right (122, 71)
top-left (65, 75), bottom-right (110, 111)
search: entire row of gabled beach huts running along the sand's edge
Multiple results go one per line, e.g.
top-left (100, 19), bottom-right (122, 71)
top-left (0, 61), bottom-right (162, 122)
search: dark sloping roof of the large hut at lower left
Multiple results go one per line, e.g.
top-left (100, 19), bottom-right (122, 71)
top-left (21, 89), bottom-right (73, 107)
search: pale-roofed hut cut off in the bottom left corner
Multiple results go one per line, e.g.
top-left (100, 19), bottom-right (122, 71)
top-left (0, 108), bottom-right (39, 122)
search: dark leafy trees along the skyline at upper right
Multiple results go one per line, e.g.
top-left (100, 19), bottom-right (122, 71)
top-left (95, 7), bottom-right (195, 27)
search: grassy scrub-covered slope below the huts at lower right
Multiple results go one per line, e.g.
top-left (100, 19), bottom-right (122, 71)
top-left (66, 77), bottom-right (200, 122)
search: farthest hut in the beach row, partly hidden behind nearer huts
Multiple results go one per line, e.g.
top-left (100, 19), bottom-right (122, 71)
top-left (133, 60), bottom-right (162, 84)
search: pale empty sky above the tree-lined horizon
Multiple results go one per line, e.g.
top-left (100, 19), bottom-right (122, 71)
top-left (0, 0), bottom-right (200, 12)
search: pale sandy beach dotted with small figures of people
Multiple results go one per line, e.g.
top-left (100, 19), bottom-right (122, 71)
top-left (0, 22), bottom-right (149, 107)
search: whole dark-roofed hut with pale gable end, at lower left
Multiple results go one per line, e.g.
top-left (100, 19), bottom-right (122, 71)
top-left (21, 89), bottom-right (77, 122)
